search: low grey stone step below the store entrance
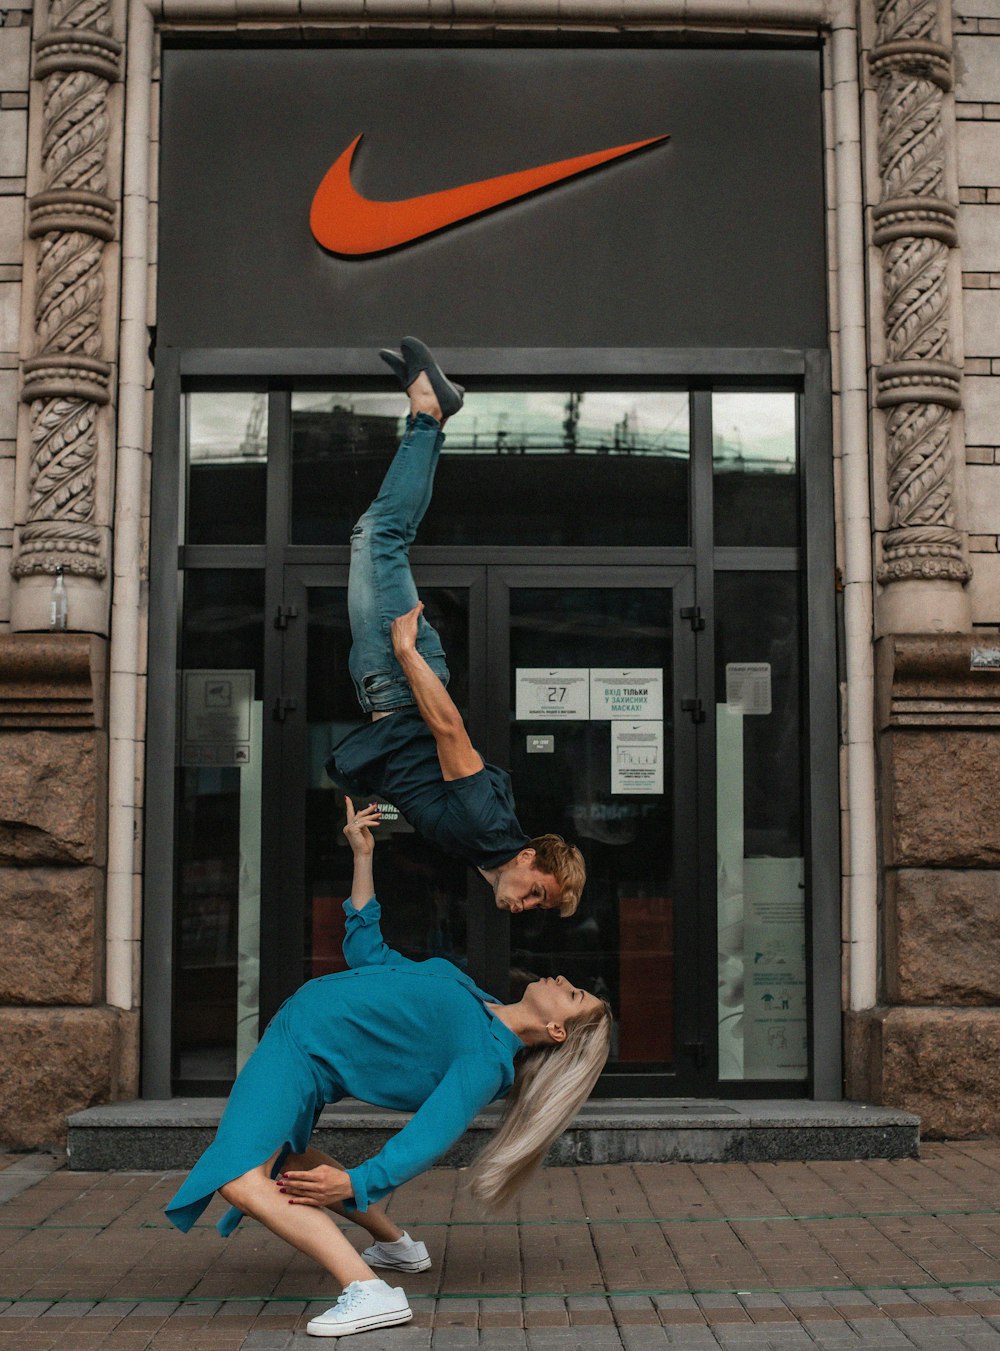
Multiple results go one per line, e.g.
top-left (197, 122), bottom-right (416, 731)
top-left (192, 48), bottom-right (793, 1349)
top-left (69, 1098), bottom-right (920, 1171)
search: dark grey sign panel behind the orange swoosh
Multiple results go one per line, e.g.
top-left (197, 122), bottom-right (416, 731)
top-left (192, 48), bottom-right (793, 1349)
top-left (157, 47), bottom-right (827, 349)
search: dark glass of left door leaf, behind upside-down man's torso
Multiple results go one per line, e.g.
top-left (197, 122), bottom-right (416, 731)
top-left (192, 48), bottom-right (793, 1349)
top-left (272, 567), bottom-right (484, 998)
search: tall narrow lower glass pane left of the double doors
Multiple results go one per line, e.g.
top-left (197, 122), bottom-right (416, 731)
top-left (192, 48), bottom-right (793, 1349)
top-left (172, 569), bottom-right (265, 1093)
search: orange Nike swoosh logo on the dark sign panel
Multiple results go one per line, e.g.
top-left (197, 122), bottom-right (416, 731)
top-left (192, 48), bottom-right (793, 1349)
top-left (309, 132), bottom-right (669, 258)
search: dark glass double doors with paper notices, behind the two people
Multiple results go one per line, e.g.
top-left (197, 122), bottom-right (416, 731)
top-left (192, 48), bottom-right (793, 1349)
top-left (264, 566), bottom-right (697, 1093)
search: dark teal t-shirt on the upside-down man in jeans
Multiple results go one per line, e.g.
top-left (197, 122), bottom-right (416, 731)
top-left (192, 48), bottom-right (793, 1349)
top-left (327, 708), bottom-right (528, 867)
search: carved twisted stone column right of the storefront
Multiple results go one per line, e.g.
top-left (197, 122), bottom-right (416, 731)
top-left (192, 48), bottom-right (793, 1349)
top-left (869, 0), bottom-right (972, 632)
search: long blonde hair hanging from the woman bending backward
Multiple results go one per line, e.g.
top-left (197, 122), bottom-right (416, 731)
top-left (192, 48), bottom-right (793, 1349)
top-left (469, 1000), bottom-right (611, 1210)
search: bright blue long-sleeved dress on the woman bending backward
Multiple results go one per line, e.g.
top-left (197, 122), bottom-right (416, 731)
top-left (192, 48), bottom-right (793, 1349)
top-left (166, 898), bottom-right (524, 1236)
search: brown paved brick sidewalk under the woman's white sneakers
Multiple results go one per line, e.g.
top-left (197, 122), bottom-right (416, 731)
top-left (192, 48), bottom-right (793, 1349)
top-left (0, 1140), bottom-right (1000, 1351)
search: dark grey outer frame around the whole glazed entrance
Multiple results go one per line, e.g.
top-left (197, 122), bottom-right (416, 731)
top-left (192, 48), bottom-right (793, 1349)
top-left (142, 346), bottom-right (843, 1100)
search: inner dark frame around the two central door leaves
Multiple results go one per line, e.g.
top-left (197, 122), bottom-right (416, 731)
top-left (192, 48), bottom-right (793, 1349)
top-left (268, 562), bottom-right (711, 1097)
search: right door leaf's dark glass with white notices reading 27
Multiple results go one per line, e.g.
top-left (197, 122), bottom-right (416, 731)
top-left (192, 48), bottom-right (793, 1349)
top-left (492, 569), bottom-right (695, 1091)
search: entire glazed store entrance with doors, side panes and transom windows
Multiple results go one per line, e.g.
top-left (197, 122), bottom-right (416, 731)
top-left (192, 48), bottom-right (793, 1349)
top-left (156, 355), bottom-right (839, 1096)
